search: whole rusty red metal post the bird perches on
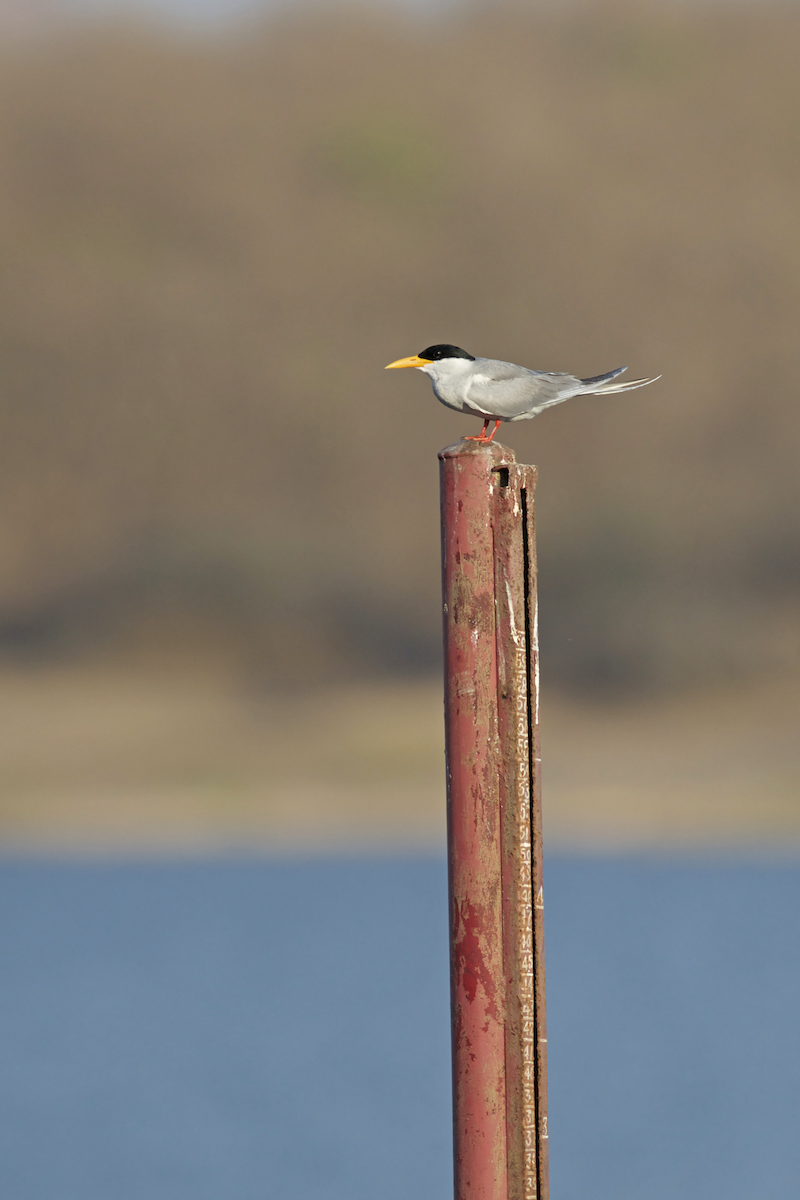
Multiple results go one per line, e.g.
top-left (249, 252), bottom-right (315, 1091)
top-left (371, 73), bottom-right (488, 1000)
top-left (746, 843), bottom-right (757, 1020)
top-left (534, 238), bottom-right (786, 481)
top-left (439, 440), bottom-right (549, 1200)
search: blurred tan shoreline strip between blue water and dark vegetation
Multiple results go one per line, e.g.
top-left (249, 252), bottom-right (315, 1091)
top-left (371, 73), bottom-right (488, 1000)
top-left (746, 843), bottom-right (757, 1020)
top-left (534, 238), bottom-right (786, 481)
top-left (0, 667), bottom-right (800, 857)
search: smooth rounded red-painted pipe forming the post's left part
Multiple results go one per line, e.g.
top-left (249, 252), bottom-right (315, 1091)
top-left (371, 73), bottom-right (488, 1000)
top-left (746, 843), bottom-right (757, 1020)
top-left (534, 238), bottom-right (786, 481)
top-left (441, 443), bottom-right (507, 1200)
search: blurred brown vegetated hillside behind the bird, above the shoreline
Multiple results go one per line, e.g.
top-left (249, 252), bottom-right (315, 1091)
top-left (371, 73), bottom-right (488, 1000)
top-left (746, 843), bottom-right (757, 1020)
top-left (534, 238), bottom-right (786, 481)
top-left (0, 0), bottom-right (800, 844)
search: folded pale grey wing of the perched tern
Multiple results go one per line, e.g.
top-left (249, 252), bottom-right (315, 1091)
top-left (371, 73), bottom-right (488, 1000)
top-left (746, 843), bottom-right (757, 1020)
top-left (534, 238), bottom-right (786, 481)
top-left (467, 359), bottom-right (583, 421)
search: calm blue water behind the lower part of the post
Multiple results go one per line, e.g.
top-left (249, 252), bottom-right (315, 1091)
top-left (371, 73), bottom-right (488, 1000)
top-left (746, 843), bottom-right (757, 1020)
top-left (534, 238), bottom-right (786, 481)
top-left (0, 859), bottom-right (800, 1200)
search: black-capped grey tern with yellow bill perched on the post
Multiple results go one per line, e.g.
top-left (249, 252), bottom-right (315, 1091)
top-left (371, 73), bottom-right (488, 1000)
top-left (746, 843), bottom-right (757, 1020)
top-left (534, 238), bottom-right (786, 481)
top-left (386, 346), bottom-right (661, 442)
